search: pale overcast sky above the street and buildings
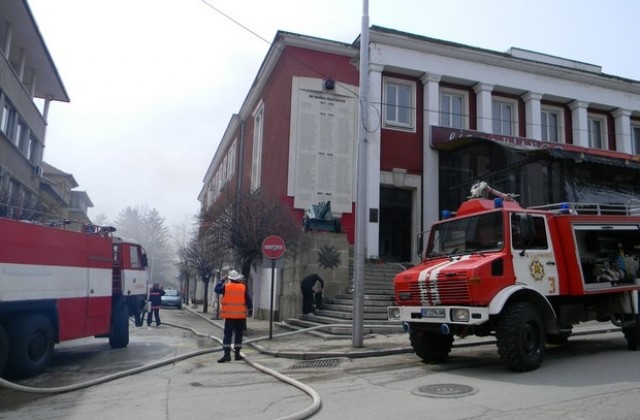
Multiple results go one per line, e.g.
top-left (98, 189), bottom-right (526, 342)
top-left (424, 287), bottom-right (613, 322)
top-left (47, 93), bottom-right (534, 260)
top-left (28, 0), bottom-right (640, 226)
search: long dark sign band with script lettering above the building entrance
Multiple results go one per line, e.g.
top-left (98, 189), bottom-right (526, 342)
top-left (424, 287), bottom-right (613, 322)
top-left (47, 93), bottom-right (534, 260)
top-left (431, 126), bottom-right (640, 171)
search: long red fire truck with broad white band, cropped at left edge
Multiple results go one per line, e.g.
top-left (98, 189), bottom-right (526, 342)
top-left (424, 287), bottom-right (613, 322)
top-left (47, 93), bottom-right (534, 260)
top-left (0, 218), bottom-right (149, 377)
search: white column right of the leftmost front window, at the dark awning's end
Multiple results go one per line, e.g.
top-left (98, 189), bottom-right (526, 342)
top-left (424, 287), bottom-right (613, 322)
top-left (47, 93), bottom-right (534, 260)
top-left (422, 74), bottom-right (442, 233)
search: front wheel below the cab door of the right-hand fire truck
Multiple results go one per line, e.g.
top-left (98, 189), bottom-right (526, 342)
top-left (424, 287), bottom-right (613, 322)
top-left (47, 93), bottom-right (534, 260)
top-left (496, 302), bottom-right (545, 372)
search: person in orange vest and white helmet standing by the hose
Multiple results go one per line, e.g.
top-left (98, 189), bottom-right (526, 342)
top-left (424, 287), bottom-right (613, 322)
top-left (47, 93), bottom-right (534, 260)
top-left (214, 270), bottom-right (253, 363)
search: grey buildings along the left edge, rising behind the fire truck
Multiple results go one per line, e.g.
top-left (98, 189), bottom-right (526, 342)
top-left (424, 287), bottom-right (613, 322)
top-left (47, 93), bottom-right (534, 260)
top-left (0, 0), bottom-right (92, 222)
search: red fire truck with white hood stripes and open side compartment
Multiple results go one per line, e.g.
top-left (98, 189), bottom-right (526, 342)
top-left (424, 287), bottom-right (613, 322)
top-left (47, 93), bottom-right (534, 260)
top-left (388, 182), bottom-right (640, 372)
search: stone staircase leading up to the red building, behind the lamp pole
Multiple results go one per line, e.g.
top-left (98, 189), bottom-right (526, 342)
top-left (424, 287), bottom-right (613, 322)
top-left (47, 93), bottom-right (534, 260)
top-left (281, 262), bottom-right (404, 338)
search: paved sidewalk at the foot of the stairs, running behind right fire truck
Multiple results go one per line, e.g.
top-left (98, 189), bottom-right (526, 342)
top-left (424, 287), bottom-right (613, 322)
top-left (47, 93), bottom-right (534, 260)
top-left (184, 306), bottom-right (620, 360)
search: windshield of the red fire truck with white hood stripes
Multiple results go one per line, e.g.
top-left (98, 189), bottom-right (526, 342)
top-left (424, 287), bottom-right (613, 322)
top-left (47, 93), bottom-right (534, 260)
top-left (426, 211), bottom-right (504, 257)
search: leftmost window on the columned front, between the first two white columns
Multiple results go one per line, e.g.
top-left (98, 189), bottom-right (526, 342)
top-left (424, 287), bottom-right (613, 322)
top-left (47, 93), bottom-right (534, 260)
top-left (383, 78), bottom-right (416, 129)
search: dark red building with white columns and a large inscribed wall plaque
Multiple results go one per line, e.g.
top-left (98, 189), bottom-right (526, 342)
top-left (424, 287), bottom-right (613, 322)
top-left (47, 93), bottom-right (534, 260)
top-left (199, 26), bottom-right (640, 318)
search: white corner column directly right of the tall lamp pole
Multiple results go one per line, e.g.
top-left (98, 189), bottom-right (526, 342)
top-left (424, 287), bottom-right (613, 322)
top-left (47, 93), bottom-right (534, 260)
top-left (365, 63), bottom-right (384, 258)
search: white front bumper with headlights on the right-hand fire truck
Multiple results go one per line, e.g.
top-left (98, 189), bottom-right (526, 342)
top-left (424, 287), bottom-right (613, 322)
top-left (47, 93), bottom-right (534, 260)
top-left (387, 306), bottom-right (489, 325)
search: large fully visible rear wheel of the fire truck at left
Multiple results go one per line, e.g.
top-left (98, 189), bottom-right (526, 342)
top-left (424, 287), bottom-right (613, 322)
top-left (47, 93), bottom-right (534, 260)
top-left (4, 314), bottom-right (55, 378)
